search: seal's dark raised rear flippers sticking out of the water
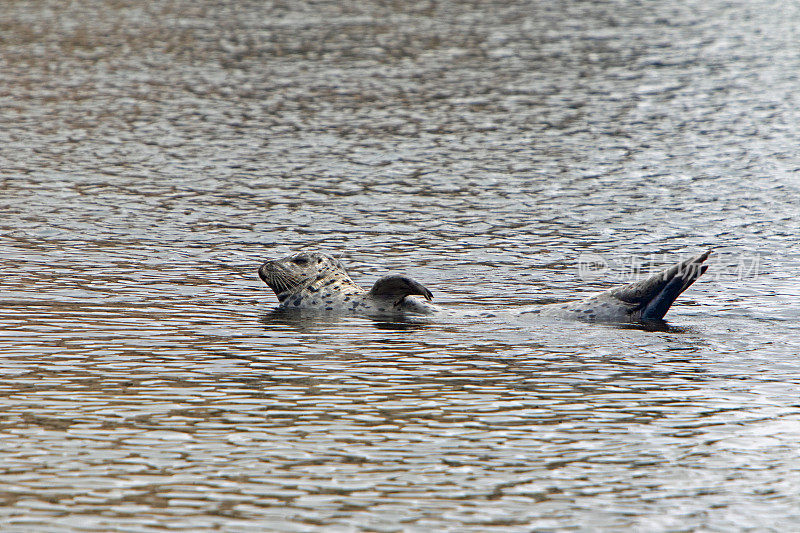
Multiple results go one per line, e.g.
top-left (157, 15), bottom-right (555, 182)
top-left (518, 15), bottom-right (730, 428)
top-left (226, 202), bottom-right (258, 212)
top-left (607, 250), bottom-right (711, 321)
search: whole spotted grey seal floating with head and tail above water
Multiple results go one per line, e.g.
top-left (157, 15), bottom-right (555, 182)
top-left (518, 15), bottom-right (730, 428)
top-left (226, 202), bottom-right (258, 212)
top-left (258, 250), bottom-right (711, 323)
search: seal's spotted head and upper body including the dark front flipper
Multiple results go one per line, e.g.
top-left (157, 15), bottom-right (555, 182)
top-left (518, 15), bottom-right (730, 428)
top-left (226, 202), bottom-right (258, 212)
top-left (258, 252), bottom-right (438, 315)
